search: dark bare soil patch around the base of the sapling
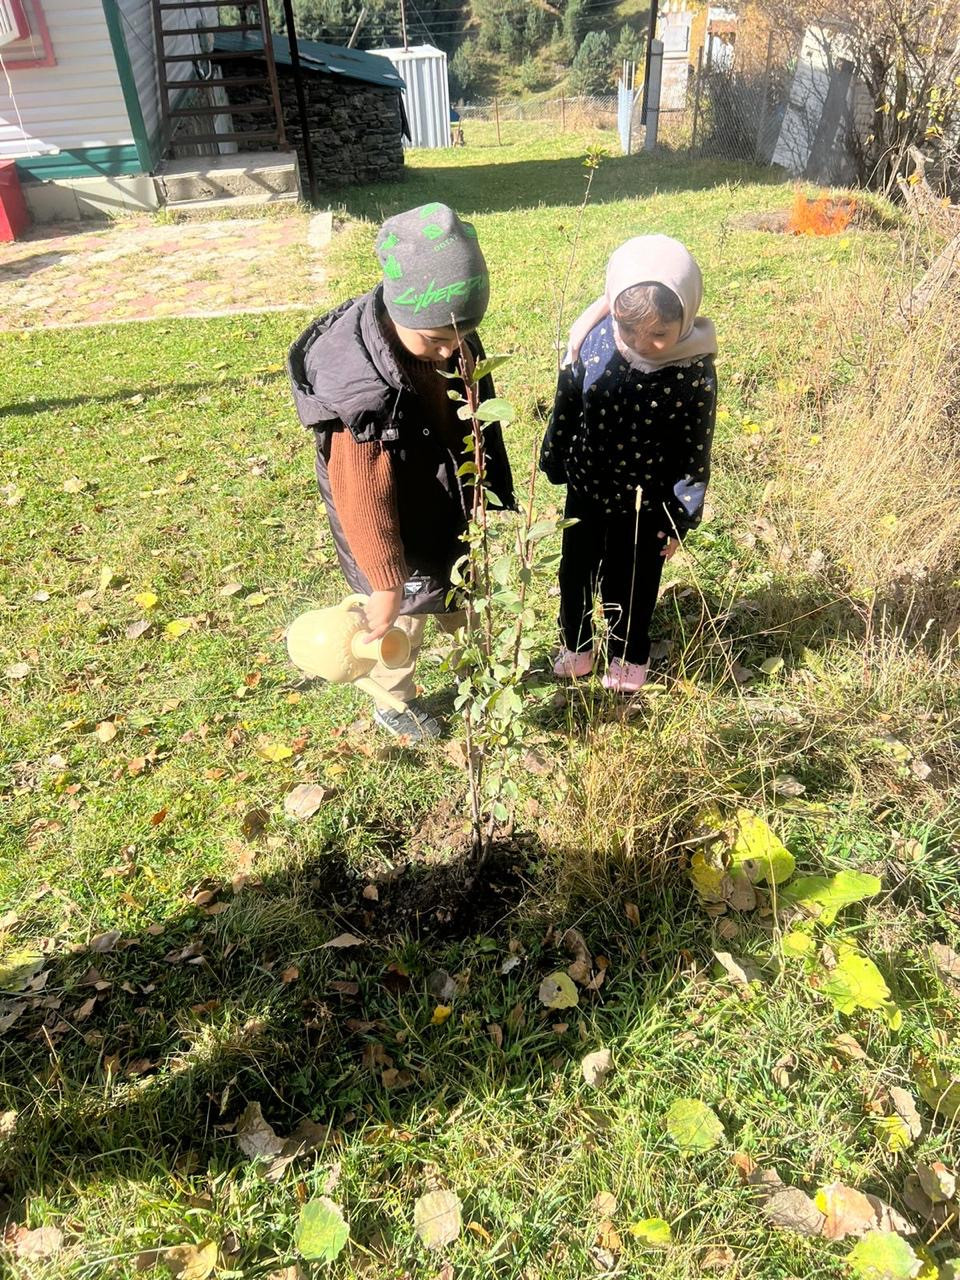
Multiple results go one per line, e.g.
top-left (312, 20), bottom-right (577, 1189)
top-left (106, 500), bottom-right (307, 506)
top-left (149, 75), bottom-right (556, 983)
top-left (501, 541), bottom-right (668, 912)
top-left (310, 838), bottom-right (536, 941)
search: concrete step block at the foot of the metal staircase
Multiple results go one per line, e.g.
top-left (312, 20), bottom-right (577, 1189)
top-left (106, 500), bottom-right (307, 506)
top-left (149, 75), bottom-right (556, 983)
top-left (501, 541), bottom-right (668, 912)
top-left (155, 151), bottom-right (300, 205)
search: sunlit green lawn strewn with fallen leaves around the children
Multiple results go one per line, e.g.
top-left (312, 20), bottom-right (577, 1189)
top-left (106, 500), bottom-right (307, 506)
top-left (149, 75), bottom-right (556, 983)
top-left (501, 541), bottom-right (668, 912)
top-left (0, 125), bottom-right (960, 1280)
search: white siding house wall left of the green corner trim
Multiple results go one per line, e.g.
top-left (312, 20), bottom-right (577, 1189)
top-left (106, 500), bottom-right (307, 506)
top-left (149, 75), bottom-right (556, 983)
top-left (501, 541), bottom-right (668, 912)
top-left (0, 0), bottom-right (133, 159)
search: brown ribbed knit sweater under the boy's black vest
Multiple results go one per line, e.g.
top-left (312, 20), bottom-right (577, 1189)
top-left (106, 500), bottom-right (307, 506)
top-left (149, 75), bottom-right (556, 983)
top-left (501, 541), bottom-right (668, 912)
top-left (326, 351), bottom-right (465, 591)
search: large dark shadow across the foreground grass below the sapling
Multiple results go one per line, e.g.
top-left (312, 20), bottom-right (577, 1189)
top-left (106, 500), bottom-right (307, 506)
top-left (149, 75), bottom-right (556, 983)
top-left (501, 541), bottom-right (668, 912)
top-left (0, 829), bottom-right (677, 1239)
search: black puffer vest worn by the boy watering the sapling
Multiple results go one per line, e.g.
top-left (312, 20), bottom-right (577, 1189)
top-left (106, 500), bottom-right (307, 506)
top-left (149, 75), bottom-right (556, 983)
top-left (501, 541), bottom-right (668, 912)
top-left (287, 287), bottom-right (516, 613)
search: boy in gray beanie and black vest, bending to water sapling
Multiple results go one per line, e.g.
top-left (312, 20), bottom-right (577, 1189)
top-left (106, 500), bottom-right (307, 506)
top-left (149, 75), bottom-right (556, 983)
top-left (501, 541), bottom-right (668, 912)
top-left (287, 204), bottom-right (515, 741)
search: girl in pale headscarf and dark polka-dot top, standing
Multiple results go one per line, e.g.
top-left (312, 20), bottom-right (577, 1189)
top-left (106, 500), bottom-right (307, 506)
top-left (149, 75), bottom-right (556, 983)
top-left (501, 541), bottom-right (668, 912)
top-left (540, 236), bottom-right (717, 694)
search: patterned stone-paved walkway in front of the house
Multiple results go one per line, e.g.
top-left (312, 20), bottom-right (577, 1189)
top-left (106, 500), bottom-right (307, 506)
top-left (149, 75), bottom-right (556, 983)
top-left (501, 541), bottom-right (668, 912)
top-left (0, 212), bottom-right (329, 330)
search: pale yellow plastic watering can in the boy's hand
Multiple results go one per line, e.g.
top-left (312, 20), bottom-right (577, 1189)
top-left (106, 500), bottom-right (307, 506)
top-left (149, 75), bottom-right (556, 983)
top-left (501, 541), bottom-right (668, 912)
top-left (287, 595), bottom-right (410, 712)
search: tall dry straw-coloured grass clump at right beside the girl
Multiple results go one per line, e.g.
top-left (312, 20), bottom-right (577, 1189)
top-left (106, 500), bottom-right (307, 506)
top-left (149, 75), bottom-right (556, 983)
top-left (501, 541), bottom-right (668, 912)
top-left (771, 207), bottom-right (960, 628)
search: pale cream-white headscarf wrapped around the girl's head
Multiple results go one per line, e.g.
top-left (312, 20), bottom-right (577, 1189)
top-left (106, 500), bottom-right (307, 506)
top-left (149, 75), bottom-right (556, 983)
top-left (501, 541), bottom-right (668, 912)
top-left (563, 236), bottom-right (717, 374)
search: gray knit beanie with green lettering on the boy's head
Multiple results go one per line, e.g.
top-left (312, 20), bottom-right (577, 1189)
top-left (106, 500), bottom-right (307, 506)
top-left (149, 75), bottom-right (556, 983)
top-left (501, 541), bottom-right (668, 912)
top-left (376, 205), bottom-right (490, 329)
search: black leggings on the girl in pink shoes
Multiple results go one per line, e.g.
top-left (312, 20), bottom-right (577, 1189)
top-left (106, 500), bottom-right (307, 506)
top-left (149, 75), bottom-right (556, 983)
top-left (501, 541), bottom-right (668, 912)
top-left (559, 492), bottom-right (667, 663)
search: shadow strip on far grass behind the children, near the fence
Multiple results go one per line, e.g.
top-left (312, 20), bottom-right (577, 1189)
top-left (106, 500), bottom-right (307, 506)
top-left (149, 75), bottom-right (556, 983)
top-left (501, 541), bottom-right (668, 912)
top-left (337, 145), bottom-right (782, 221)
